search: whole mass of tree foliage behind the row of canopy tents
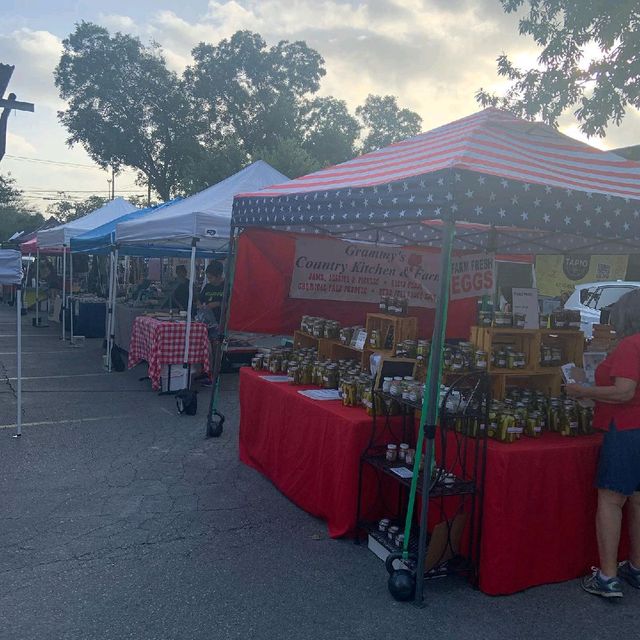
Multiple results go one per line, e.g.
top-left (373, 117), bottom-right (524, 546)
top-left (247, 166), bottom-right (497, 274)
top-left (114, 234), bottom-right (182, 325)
top-left (55, 22), bottom-right (421, 198)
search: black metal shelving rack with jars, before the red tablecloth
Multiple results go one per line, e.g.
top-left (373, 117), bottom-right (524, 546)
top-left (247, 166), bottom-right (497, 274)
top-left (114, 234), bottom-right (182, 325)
top-left (357, 372), bottom-right (491, 584)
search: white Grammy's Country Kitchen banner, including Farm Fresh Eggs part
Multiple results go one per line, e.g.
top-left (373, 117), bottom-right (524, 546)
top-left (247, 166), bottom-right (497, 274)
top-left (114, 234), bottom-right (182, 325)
top-left (289, 237), bottom-right (495, 308)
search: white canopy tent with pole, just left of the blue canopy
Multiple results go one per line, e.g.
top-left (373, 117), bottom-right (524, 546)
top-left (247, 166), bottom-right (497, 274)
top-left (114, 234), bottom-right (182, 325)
top-left (36, 198), bottom-right (137, 341)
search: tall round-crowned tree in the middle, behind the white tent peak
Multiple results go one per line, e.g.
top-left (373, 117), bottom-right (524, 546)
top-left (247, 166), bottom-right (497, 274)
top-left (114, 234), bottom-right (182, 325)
top-left (184, 31), bottom-right (325, 158)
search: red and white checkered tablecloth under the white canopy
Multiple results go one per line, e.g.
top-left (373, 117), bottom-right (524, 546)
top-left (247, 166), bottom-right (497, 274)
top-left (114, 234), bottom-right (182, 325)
top-left (129, 316), bottom-right (211, 389)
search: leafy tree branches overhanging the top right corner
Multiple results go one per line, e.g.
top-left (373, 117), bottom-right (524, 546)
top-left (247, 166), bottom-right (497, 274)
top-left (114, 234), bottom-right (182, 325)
top-left (476, 0), bottom-right (640, 136)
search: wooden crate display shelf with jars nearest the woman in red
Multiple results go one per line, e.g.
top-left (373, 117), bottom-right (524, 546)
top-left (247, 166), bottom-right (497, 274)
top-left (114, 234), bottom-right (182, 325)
top-left (471, 327), bottom-right (584, 400)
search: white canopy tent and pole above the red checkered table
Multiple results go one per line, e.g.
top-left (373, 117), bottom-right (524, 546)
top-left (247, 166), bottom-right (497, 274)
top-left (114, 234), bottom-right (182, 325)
top-left (116, 160), bottom-right (288, 380)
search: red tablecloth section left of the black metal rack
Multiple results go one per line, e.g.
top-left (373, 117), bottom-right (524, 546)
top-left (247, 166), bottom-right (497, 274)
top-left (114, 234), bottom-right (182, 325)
top-left (240, 368), bottom-right (400, 538)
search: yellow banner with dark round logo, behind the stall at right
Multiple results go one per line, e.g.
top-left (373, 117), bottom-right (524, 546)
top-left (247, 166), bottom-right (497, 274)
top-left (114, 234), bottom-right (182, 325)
top-left (536, 255), bottom-right (629, 296)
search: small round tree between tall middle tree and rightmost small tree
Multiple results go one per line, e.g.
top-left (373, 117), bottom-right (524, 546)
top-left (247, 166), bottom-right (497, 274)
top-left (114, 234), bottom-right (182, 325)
top-left (300, 97), bottom-right (361, 166)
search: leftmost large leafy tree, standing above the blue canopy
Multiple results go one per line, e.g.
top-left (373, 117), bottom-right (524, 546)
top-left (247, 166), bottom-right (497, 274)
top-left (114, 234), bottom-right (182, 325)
top-left (54, 22), bottom-right (197, 200)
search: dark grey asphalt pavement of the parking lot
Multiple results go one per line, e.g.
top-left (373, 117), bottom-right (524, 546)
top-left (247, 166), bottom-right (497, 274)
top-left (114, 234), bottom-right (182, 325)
top-left (0, 304), bottom-right (640, 640)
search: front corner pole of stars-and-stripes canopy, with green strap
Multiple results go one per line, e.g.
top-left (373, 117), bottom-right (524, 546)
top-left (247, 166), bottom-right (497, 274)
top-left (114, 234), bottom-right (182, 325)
top-left (415, 220), bottom-right (456, 605)
